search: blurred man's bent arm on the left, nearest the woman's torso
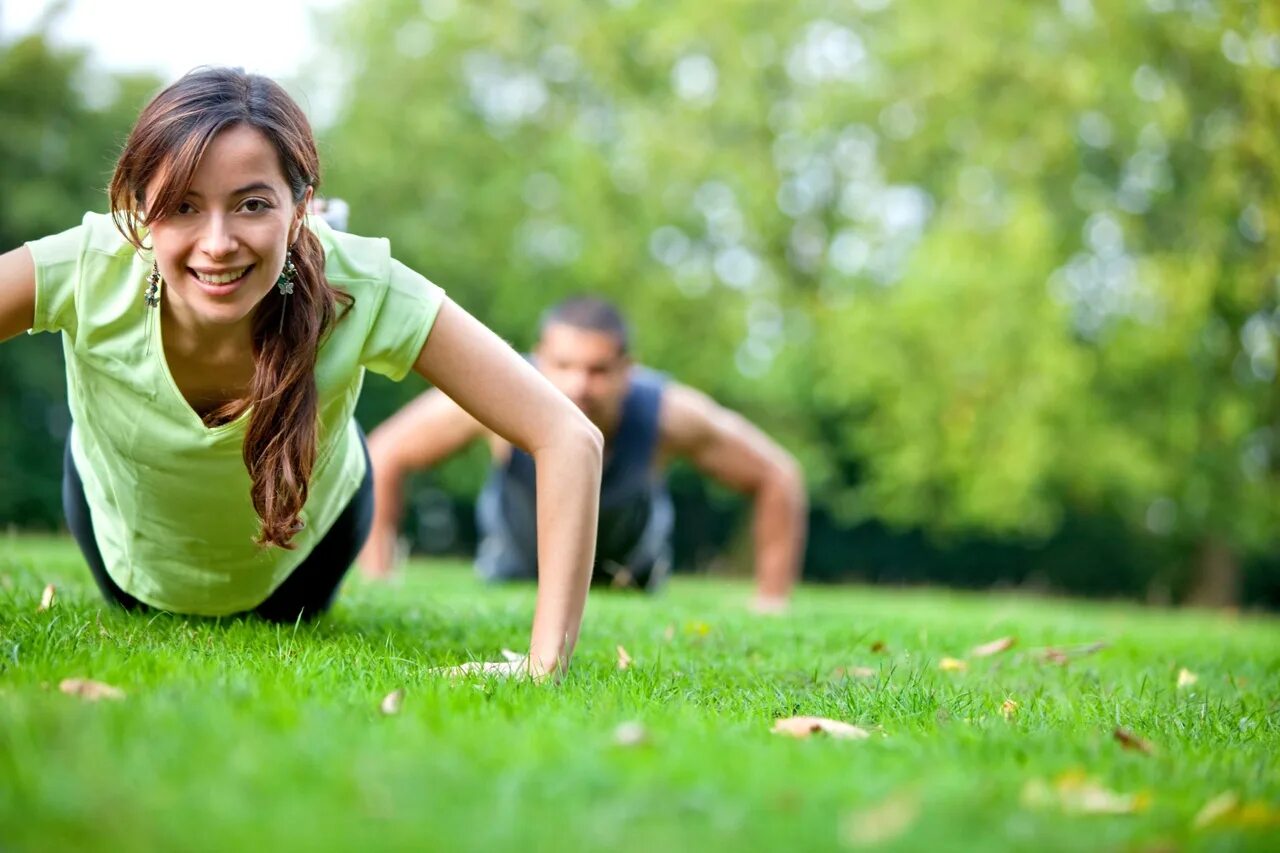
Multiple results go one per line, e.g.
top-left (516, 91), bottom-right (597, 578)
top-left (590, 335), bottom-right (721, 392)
top-left (358, 388), bottom-right (485, 578)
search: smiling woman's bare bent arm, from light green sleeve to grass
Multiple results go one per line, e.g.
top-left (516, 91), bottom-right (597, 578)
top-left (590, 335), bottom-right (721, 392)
top-left (413, 300), bottom-right (604, 678)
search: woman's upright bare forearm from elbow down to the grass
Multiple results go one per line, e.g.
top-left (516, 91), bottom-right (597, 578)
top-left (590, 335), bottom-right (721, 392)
top-left (530, 418), bottom-right (603, 675)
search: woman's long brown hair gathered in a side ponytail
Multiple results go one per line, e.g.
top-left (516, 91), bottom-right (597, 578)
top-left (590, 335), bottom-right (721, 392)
top-left (110, 68), bottom-right (352, 548)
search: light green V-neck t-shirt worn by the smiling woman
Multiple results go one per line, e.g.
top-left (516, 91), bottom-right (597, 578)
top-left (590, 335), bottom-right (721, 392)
top-left (27, 214), bottom-right (444, 616)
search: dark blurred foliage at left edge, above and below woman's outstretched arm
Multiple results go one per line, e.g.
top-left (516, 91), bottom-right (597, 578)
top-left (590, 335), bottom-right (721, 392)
top-left (0, 35), bottom-right (159, 526)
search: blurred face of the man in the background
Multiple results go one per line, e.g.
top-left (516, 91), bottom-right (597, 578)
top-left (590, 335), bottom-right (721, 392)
top-left (534, 323), bottom-right (631, 429)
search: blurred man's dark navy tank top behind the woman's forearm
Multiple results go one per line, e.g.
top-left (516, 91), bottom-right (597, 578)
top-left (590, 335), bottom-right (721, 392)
top-left (477, 368), bottom-right (666, 576)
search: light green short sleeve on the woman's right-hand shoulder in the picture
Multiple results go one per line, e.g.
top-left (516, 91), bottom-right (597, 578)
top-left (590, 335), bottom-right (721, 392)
top-left (360, 259), bottom-right (444, 380)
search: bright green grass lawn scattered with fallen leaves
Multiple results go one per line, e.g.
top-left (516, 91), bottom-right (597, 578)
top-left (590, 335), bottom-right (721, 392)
top-left (0, 537), bottom-right (1280, 853)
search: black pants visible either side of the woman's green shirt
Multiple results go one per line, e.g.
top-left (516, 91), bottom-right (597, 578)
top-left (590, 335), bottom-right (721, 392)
top-left (63, 433), bottom-right (374, 622)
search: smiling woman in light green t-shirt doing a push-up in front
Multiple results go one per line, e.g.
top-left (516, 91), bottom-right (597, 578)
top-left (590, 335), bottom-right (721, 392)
top-left (0, 68), bottom-right (602, 676)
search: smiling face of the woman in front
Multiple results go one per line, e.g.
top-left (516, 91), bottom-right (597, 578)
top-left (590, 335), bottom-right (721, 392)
top-left (147, 124), bottom-right (311, 325)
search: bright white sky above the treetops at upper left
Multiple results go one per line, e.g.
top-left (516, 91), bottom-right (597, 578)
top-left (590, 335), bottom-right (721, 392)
top-left (0, 0), bottom-right (342, 82)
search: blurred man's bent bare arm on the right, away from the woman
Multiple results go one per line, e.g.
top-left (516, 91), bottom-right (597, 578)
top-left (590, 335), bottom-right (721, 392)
top-left (662, 383), bottom-right (808, 611)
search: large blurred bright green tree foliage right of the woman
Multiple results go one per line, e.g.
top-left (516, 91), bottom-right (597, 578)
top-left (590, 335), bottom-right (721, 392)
top-left (314, 0), bottom-right (1280, 578)
